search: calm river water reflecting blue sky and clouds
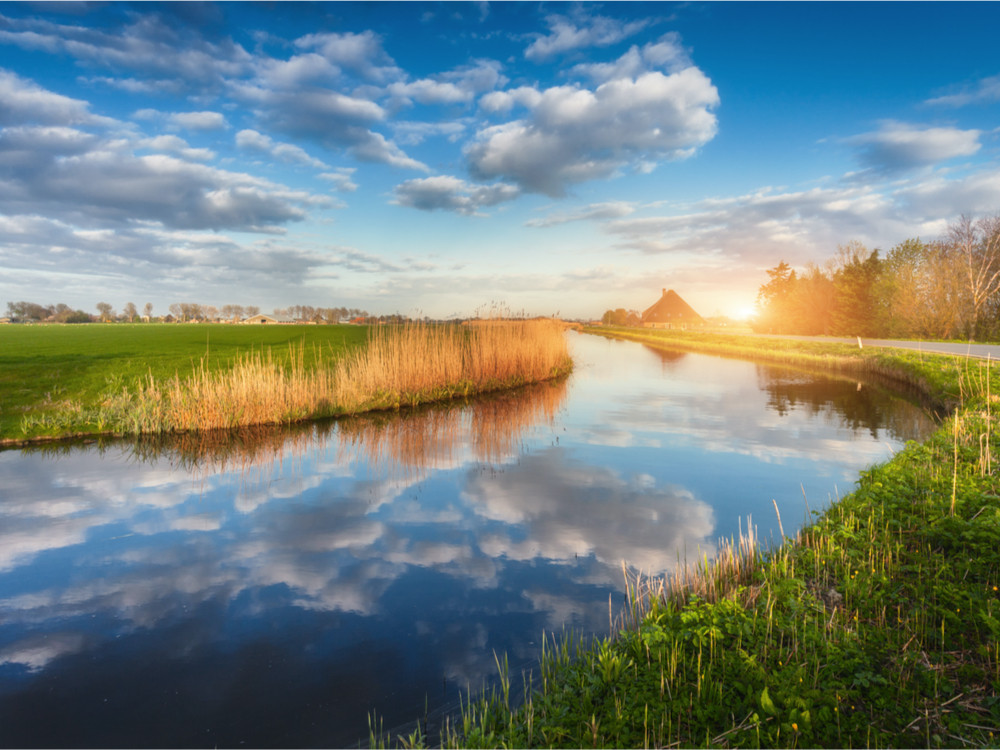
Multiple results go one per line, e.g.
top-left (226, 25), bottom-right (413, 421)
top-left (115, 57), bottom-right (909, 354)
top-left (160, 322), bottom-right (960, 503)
top-left (0, 334), bottom-right (933, 747)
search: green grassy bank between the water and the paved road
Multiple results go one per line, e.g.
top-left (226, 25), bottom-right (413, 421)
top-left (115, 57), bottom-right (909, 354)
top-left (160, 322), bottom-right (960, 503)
top-left (428, 329), bottom-right (1000, 747)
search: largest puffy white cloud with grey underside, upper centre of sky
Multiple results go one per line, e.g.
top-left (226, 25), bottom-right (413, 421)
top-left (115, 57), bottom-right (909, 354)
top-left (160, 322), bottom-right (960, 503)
top-left (465, 67), bottom-right (719, 197)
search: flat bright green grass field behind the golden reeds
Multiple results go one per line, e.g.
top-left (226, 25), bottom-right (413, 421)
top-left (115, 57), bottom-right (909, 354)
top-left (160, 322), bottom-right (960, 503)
top-left (0, 323), bottom-right (368, 440)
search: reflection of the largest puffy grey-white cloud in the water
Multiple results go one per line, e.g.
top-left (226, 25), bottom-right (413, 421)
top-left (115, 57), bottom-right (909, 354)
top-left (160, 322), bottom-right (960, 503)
top-left (464, 449), bottom-right (715, 574)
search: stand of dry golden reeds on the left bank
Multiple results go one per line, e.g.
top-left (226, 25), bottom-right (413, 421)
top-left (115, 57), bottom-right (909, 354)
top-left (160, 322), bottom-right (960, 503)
top-left (99, 320), bottom-right (570, 434)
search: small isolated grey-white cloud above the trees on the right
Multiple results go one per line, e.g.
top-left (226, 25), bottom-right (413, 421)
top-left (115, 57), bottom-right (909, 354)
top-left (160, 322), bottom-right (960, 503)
top-left (847, 122), bottom-right (982, 173)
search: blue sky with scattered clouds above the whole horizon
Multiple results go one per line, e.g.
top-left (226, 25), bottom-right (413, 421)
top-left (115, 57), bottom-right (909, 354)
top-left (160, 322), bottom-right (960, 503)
top-left (0, 2), bottom-right (1000, 318)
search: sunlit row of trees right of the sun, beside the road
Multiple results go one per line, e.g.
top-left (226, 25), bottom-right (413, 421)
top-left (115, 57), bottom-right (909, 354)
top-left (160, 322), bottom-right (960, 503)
top-left (752, 214), bottom-right (1000, 340)
